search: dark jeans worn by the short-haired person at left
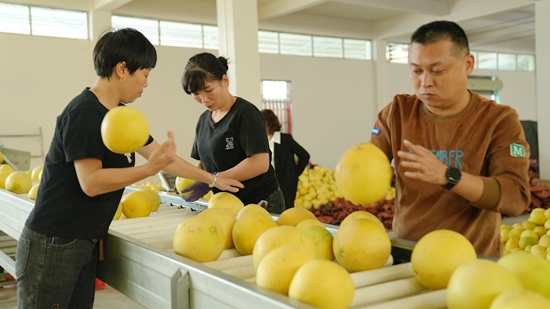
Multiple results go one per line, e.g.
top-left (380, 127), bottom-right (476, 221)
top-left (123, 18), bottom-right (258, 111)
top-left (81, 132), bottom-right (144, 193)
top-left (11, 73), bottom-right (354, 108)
top-left (15, 227), bottom-right (99, 309)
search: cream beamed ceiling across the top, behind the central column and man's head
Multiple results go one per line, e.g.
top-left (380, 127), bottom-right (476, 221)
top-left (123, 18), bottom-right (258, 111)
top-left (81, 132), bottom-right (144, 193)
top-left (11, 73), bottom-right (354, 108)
top-left (103, 0), bottom-right (548, 54)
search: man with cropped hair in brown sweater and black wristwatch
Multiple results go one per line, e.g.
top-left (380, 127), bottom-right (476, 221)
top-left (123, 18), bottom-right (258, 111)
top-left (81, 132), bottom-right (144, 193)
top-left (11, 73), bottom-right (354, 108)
top-left (370, 21), bottom-right (530, 258)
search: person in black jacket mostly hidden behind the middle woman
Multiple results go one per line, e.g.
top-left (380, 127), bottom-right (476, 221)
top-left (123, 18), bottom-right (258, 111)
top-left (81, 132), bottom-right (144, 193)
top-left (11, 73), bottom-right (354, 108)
top-left (262, 109), bottom-right (309, 208)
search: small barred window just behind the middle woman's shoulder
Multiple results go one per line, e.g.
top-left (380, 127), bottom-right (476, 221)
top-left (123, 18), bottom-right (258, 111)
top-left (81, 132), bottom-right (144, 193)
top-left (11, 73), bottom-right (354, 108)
top-left (262, 80), bottom-right (292, 133)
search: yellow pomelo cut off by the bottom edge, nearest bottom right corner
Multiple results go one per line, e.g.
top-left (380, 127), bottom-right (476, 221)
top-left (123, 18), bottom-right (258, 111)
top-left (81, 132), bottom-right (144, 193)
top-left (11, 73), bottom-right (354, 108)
top-left (489, 289), bottom-right (550, 309)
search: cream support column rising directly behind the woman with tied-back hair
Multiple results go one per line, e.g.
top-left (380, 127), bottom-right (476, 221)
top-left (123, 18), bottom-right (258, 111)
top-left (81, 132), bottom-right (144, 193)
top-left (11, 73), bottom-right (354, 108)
top-left (217, 0), bottom-right (263, 109)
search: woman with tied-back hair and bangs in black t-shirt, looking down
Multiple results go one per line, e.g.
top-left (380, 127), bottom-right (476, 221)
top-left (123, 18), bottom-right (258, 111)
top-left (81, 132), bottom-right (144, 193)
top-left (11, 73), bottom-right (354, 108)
top-left (182, 53), bottom-right (285, 214)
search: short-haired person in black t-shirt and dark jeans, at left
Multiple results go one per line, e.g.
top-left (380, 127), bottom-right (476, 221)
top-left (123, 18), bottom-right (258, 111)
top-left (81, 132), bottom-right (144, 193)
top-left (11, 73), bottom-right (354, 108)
top-left (15, 28), bottom-right (242, 309)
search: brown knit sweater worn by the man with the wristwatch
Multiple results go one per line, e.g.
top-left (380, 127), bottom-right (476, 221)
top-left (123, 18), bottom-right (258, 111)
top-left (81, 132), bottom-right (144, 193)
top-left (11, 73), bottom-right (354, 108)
top-left (371, 92), bottom-right (530, 258)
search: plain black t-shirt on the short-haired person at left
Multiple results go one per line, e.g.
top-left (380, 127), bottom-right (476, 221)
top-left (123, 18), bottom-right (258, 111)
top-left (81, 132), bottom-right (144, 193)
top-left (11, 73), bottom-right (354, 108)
top-left (25, 88), bottom-right (152, 239)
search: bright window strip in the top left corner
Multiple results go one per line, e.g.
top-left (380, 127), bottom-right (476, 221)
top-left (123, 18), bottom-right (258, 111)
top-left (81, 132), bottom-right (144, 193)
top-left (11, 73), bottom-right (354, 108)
top-left (0, 2), bottom-right (88, 39)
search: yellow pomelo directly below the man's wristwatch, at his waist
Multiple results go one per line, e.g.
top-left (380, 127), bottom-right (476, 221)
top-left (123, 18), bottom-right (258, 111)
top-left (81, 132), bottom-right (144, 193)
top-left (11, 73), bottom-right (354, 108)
top-left (411, 229), bottom-right (477, 290)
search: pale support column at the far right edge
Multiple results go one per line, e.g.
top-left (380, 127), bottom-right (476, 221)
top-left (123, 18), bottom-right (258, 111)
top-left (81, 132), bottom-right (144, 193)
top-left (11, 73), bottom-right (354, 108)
top-left (535, 1), bottom-right (550, 179)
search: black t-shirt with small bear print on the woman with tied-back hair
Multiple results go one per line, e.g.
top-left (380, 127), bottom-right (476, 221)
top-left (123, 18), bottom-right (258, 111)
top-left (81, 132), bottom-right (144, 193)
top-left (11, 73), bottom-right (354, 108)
top-left (191, 98), bottom-right (279, 205)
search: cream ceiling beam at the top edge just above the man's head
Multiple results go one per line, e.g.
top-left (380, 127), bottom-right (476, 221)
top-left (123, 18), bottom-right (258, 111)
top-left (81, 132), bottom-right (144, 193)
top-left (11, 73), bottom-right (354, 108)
top-left (333, 0), bottom-right (450, 16)
